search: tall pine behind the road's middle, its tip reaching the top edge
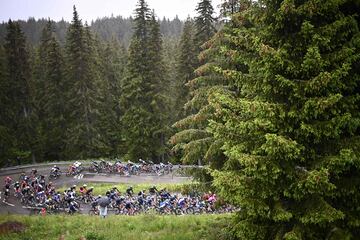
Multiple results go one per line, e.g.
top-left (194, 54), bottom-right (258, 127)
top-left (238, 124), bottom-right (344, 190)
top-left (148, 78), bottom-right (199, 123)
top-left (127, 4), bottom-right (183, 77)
top-left (120, 0), bottom-right (166, 160)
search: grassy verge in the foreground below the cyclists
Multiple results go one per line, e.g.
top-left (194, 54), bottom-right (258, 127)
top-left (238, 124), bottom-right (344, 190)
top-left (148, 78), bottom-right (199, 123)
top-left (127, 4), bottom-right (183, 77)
top-left (0, 215), bottom-right (231, 240)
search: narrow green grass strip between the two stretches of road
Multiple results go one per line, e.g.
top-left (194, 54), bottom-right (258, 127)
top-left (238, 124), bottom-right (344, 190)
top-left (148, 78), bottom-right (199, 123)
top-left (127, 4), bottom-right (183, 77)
top-left (59, 182), bottom-right (201, 196)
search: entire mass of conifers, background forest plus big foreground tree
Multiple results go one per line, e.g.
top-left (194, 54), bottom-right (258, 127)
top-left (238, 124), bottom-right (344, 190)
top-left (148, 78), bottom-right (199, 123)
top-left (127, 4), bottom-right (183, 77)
top-left (0, 0), bottom-right (360, 240)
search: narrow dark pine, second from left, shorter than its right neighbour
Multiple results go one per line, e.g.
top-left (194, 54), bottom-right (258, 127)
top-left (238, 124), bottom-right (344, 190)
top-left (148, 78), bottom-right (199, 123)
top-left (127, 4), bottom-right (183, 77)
top-left (36, 20), bottom-right (66, 160)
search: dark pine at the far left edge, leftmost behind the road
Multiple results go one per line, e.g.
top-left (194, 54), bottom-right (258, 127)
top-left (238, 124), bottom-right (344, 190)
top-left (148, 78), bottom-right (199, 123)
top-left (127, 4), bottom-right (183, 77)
top-left (0, 20), bottom-right (36, 162)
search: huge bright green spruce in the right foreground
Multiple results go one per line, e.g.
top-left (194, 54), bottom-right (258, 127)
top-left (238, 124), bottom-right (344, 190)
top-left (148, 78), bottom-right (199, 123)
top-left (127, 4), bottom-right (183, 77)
top-left (210, 0), bottom-right (360, 240)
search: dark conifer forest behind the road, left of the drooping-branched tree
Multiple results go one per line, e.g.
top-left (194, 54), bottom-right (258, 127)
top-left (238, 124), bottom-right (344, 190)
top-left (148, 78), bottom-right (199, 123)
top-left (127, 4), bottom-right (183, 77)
top-left (0, 1), bottom-right (215, 166)
